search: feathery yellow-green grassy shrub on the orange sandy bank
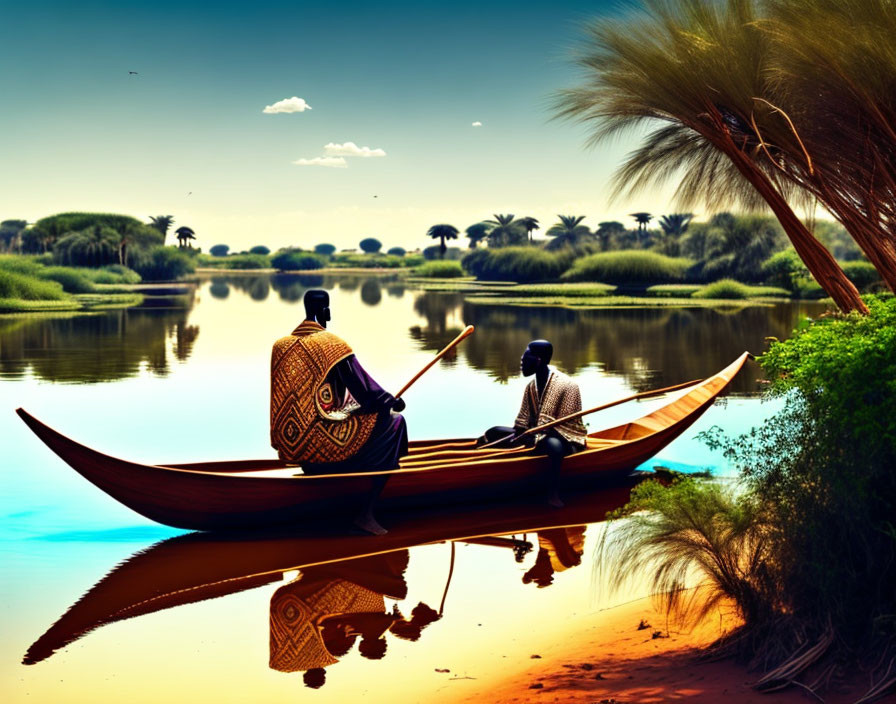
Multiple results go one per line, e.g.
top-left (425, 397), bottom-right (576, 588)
top-left (598, 478), bottom-right (778, 626)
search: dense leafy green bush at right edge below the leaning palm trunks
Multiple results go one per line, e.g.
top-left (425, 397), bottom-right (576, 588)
top-left (710, 296), bottom-right (896, 647)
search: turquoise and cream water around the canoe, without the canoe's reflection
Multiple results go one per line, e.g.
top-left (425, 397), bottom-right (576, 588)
top-left (0, 277), bottom-right (814, 702)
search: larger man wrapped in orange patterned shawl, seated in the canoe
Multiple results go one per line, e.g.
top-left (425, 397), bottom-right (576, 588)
top-left (271, 289), bottom-right (408, 535)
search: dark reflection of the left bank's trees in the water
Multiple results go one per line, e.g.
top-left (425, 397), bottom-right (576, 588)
top-left (0, 308), bottom-right (199, 384)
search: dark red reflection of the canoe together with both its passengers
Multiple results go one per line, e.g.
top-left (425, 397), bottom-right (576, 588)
top-left (23, 473), bottom-right (649, 676)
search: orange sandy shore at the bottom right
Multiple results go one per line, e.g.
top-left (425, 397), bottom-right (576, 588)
top-left (452, 599), bottom-right (861, 704)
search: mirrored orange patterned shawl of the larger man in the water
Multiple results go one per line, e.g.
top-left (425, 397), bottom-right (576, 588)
top-left (268, 579), bottom-right (386, 672)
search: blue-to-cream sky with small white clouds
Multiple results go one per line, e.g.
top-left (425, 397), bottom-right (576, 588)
top-left (0, 0), bottom-right (674, 251)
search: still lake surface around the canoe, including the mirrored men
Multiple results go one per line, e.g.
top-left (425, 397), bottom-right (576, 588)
top-left (0, 275), bottom-right (823, 703)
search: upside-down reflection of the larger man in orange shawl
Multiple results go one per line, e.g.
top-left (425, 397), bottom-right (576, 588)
top-left (269, 550), bottom-right (440, 689)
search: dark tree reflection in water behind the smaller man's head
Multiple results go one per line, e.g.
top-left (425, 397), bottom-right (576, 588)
top-left (410, 292), bottom-right (808, 393)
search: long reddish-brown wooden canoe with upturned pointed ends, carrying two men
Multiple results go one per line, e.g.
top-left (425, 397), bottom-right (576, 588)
top-left (16, 352), bottom-right (749, 530)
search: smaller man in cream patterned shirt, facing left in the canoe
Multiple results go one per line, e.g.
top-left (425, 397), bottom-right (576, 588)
top-left (483, 340), bottom-right (586, 508)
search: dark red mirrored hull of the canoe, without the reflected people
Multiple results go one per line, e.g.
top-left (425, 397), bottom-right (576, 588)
top-left (23, 473), bottom-right (650, 665)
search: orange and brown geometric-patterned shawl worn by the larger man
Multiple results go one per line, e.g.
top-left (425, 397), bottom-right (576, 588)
top-left (271, 320), bottom-right (376, 464)
